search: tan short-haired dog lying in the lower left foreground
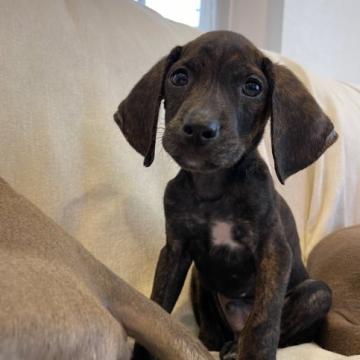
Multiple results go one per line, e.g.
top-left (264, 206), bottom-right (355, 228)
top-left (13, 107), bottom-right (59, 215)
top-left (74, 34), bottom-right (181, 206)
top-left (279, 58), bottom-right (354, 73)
top-left (0, 178), bottom-right (212, 360)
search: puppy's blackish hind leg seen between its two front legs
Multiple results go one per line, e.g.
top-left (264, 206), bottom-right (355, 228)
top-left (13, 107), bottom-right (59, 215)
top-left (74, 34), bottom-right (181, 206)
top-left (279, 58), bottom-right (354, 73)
top-left (191, 267), bottom-right (234, 351)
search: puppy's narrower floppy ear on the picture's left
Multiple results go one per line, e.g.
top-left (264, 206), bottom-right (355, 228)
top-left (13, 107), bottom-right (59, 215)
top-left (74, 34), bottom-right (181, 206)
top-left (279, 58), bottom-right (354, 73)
top-left (114, 46), bottom-right (181, 166)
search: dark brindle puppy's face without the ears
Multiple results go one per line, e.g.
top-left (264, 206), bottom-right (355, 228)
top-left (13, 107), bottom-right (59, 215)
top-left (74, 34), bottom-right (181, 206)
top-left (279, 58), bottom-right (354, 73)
top-left (163, 33), bottom-right (269, 172)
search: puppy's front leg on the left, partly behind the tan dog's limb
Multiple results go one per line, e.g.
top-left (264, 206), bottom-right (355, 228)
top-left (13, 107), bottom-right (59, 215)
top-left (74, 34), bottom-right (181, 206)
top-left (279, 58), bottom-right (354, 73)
top-left (133, 231), bottom-right (192, 360)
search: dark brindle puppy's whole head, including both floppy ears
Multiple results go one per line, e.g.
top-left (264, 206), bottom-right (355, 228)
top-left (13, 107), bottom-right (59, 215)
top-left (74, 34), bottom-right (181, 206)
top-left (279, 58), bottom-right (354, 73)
top-left (114, 31), bottom-right (337, 182)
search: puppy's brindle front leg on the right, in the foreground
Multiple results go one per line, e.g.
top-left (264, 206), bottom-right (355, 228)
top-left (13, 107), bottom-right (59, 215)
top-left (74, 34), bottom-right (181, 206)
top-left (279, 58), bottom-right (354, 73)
top-left (238, 229), bottom-right (292, 360)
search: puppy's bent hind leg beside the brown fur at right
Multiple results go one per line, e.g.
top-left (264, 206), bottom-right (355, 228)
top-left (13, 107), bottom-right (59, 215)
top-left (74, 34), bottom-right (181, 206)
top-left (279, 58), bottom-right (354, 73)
top-left (279, 279), bottom-right (331, 347)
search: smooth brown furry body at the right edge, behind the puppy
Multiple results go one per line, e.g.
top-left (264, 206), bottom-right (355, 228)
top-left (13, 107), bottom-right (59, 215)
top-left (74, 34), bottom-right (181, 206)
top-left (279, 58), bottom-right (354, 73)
top-left (308, 226), bottom-right (360, 355)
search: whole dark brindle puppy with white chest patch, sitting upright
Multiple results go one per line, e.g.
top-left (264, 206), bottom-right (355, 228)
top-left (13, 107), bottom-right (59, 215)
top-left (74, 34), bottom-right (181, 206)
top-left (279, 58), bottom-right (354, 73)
top-left (115, 31), bottom-right (337, 360)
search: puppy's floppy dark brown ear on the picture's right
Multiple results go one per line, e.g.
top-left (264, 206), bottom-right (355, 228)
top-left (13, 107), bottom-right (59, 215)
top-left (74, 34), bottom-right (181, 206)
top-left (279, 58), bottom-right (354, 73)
top-left (264, 59), bottom-right (337, 184)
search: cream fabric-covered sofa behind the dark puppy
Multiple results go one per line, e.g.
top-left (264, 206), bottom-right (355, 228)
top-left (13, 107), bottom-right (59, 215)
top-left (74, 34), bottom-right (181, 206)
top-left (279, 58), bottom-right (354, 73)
top-left (0, 0), bottom-right (360, 360)
